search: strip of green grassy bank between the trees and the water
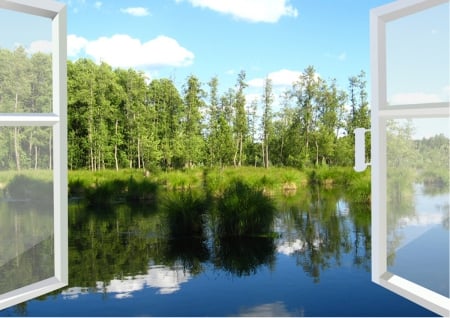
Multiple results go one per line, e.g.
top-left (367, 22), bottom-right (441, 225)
top-left (69, 167), bottom-right (370, 205)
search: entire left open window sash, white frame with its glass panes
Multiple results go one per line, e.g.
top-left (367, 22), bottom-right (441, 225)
top-left (0, 0), bottom-right (68, 310)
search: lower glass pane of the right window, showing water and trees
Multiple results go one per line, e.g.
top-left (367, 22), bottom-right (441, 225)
top-left (386, 118), bottom-right (450, 297)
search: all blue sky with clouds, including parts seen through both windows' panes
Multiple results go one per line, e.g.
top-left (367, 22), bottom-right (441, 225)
top-left (0, 0), bottom-right (450, 132)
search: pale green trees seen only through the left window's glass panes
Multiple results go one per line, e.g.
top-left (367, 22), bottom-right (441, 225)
top-left (0, 47), bottom-right (52, 170)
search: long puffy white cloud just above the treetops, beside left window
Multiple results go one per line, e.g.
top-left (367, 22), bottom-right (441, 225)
top-left (68, 34), bottom-right (194, 68)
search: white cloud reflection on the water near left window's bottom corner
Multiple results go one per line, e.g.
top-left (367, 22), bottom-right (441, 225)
top-left (61, 265), bottom-right (191, 299)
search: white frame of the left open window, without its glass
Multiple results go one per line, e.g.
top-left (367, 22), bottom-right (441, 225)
top-left (0, 0), bottom-right (68, 310)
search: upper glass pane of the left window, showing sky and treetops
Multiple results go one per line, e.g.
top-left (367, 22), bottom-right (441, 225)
top-left (0, 9), bottom-right (52, 113)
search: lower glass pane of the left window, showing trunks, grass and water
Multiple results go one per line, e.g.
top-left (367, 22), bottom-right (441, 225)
top-left (0, 127), bottom-right (54, 294)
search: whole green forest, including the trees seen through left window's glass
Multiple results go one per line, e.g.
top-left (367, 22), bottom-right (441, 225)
top-left (0, 47), bottom-right (370, 171)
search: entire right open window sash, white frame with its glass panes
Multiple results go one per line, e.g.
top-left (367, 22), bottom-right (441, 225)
top-left (371, 0), bottom-right (450, 316)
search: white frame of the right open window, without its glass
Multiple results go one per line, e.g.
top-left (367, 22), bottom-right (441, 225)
top-left (370, 0), bottom-right (450, 316)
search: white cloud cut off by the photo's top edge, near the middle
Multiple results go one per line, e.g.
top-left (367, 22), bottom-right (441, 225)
top-left (176, 0), bottom-right (298, 23)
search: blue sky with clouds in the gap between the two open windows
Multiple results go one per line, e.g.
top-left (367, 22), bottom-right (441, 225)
top-left (60, 0), bottom-right (398, 99)
